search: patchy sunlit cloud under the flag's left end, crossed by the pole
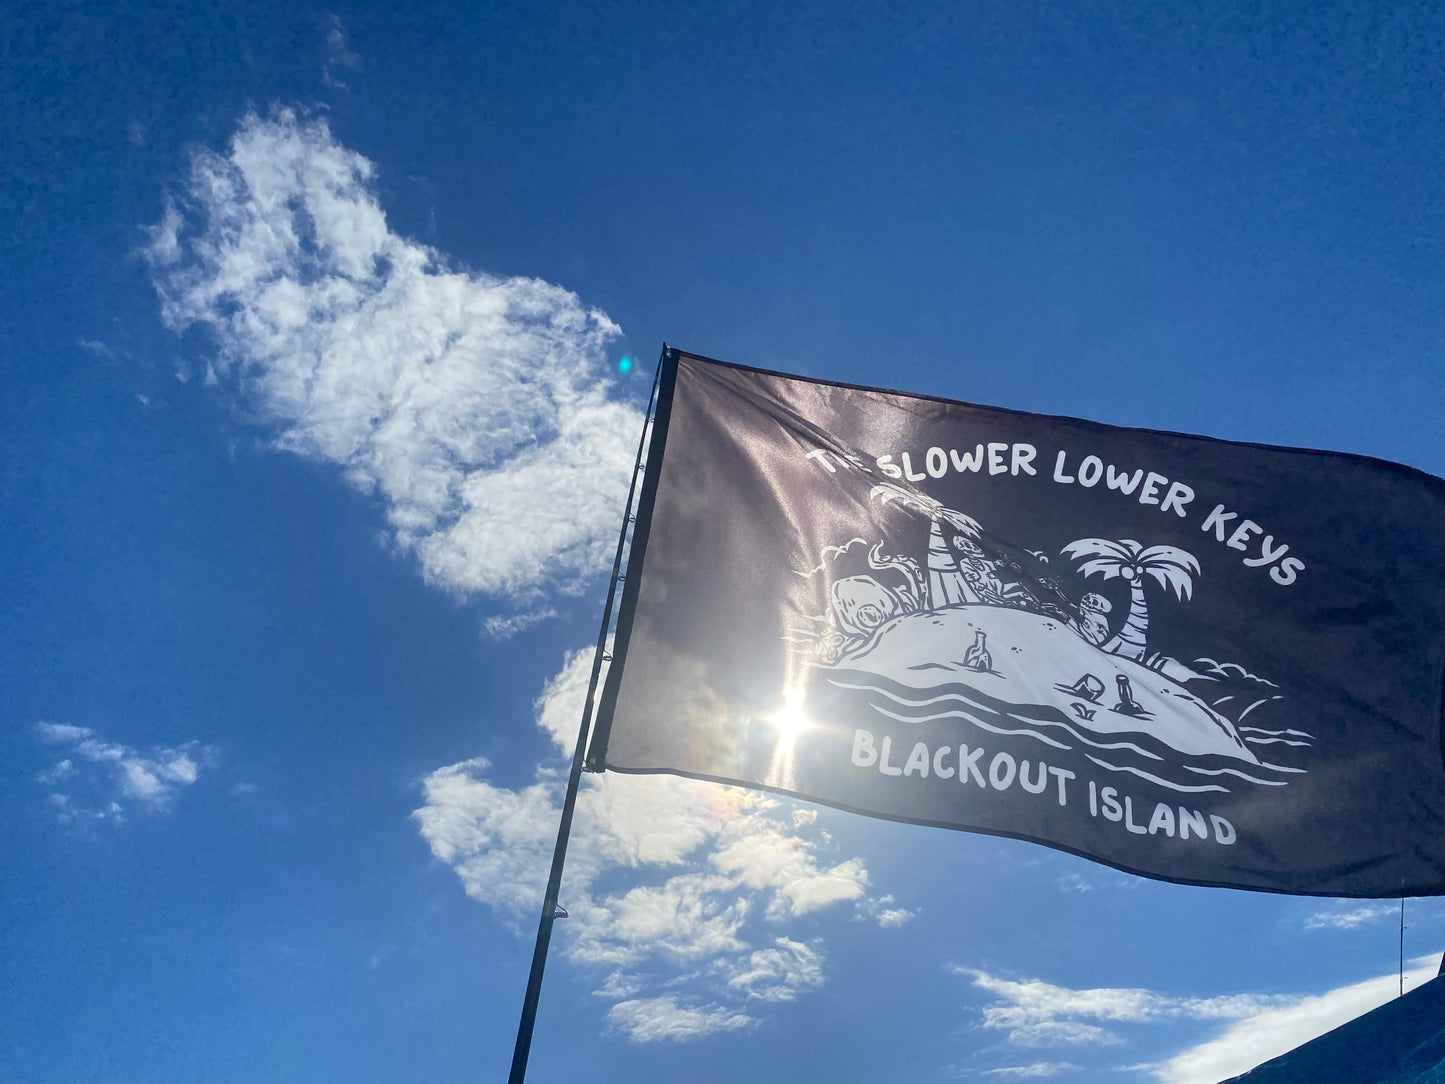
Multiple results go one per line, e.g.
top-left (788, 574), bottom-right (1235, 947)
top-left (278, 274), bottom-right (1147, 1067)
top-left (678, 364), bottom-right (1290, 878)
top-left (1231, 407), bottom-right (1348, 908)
top-left (413, 652), bottom-right (906, 1042)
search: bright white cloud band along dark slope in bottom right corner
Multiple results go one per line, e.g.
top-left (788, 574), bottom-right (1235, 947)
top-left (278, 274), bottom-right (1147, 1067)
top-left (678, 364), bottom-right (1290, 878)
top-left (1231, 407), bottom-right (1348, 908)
top-left (1140, 955), bottom-right (1439, 1084)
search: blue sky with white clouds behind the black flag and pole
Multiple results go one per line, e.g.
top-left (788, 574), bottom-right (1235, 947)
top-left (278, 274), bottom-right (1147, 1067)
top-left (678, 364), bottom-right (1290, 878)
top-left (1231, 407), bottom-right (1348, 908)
top-left (0, 3), bottom-right (1445, 1084)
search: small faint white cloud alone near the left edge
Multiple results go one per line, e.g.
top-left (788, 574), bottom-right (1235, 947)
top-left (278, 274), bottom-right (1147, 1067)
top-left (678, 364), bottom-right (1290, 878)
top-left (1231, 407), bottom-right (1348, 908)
top-left (35, 723), bottom-right (214, 824)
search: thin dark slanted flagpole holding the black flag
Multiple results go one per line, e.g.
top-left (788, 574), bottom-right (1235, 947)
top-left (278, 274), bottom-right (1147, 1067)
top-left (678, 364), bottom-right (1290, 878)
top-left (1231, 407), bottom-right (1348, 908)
top-left (507, 343), bottom-right (668, 1084)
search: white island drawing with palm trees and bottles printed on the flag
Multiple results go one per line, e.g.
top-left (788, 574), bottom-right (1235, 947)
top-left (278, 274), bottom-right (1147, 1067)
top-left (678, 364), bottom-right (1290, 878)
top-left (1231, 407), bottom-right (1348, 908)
top-left (788, 484), bottom-right (1314, 791)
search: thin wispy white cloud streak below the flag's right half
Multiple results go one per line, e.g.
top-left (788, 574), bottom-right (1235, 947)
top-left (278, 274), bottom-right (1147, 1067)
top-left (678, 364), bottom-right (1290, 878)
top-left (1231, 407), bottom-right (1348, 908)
top-left (952, 967), bottom-right (1296, 1046)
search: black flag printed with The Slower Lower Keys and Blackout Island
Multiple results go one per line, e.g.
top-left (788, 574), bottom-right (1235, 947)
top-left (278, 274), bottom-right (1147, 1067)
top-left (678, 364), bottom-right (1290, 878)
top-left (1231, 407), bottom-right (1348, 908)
top-left (588, 351), bottom-right (1445, 896)
